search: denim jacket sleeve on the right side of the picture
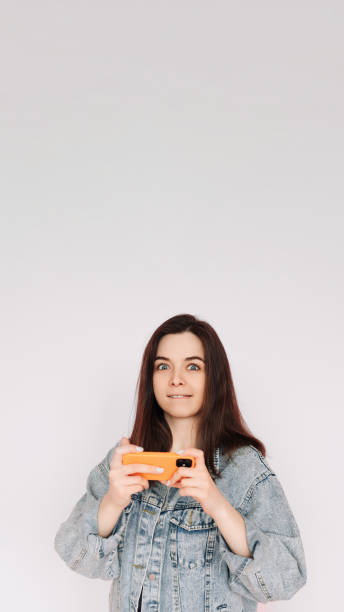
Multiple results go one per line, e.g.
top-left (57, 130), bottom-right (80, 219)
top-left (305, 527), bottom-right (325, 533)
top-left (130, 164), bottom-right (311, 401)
top-left (220, 473), bottom-right (307, 603)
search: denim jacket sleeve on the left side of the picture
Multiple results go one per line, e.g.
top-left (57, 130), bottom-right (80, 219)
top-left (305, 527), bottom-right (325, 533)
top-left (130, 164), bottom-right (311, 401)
top-left (54, 445), bottom-right (129, 580)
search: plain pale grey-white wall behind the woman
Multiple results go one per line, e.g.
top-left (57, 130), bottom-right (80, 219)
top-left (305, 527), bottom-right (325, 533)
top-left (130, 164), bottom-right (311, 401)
top-left (0, 0), bottom-right (344, 612)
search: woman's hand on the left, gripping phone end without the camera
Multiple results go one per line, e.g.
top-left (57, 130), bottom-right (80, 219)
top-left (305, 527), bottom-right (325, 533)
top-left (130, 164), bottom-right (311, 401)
top-left (107, 438), bottom-right (159, 510)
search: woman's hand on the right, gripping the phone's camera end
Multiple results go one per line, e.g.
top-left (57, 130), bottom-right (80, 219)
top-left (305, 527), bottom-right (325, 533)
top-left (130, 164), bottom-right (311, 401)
top-left (161, 448), bottom-right (224, 516)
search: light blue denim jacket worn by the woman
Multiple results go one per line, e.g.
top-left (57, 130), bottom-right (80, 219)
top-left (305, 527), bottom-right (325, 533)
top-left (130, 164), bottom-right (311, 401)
top-left (54, 441), bottom-right (307, 612)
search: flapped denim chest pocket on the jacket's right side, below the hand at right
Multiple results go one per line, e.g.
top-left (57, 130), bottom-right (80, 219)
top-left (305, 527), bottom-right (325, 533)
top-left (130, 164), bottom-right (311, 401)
top-left (170, 507), bottom-right (217, 571)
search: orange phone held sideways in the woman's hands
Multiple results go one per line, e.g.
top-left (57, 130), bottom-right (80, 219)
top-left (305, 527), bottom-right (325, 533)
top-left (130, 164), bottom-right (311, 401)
top-left (122, 451), bottom-right (196, 480)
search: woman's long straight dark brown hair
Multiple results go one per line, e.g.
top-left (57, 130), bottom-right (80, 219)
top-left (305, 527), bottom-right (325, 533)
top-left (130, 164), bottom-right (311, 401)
top-left (129, 314), bottom-right (266, 482)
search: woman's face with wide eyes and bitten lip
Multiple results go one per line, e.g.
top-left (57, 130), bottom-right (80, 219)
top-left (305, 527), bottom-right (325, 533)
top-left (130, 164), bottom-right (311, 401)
top-left (153, 332), bottom-right (205, 420)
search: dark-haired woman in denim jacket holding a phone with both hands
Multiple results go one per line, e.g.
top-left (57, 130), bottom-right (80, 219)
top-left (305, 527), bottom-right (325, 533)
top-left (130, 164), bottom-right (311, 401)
top-left (55, 314), bottom-right (307, 612)
